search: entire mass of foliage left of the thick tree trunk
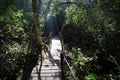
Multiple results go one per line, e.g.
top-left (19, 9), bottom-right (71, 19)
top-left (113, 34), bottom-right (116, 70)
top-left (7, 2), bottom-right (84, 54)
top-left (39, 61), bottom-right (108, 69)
top-left (0, 6), bottom-right (29, 80)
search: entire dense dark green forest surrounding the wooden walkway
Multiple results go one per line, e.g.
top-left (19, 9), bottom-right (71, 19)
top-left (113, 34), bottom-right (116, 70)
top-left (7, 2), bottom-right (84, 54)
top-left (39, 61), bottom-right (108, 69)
top-left (0, 0), bottom-right (120, 80)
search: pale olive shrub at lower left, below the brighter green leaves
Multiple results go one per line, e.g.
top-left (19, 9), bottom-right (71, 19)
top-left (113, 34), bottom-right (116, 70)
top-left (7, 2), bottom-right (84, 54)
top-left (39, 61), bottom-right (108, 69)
top-left (0, 42), bottom-right (28, 80)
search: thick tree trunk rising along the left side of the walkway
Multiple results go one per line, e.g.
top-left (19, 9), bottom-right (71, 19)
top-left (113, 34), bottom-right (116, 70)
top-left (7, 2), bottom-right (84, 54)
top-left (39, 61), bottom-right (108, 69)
top-left (22, 0), bottom-right (42, 80)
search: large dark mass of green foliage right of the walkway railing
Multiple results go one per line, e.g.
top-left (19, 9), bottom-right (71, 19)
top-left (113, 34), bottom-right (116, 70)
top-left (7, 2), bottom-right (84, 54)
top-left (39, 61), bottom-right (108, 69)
top-left (63, 0), bottom-right (120, 80)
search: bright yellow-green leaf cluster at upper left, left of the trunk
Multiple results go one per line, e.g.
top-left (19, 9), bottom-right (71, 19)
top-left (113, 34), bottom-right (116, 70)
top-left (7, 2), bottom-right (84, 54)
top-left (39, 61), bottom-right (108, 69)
top-left (0, 10), bottom-right (24, 37)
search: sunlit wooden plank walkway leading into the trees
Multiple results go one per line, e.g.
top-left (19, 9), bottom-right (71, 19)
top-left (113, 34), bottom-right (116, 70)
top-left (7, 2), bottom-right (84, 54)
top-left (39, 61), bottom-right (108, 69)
top-left (30, 38), bottom-right (61, 80)
